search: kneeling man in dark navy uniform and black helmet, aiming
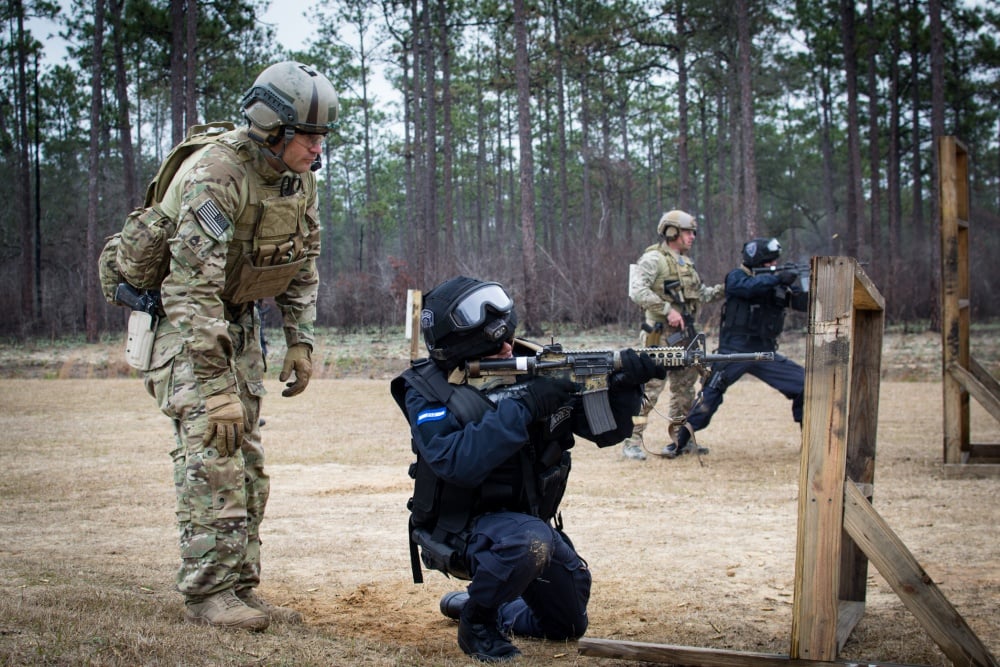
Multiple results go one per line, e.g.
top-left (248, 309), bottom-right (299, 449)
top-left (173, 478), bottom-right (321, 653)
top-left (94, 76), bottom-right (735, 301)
top-left (391, 276), bottom-right (666, 662)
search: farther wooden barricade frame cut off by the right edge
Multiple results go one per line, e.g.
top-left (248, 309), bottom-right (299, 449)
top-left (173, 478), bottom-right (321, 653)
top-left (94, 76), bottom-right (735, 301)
top-left (938, 136), bottom-right (1000, 476)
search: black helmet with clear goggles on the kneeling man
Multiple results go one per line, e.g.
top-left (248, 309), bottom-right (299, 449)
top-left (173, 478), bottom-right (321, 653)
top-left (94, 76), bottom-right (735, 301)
top-left (420, 276), bottom-right (517, 370)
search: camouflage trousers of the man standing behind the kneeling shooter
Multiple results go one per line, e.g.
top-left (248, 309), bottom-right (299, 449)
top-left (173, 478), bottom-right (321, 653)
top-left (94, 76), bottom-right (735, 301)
top-left (144, 310), bottom-right (270, 602)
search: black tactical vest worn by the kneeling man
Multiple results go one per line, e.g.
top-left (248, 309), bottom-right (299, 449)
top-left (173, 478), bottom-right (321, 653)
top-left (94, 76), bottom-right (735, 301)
top-left (390, 359), bottom-right (572, 583)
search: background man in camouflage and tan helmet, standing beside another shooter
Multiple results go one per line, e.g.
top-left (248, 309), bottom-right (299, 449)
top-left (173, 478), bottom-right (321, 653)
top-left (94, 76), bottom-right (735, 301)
top-left (622, 210), bottom-right (723, 461)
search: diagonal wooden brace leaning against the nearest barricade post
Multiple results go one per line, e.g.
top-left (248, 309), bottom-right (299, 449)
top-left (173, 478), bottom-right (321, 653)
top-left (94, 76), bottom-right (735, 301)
top-left (844, 482), bottom-right (998, 667)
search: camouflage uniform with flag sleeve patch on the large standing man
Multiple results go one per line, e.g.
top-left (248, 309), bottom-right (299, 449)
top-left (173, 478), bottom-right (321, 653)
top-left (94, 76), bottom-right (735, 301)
top-left (144, 129), bottom-right (320, 601)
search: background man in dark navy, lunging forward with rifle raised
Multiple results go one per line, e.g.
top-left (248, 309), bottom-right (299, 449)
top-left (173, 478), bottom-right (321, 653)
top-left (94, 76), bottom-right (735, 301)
top-left (664, 238), bottom-right (809, 458)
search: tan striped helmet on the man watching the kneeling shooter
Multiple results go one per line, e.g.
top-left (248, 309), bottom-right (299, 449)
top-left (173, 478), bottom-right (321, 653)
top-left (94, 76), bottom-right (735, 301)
top-left (240, 60), bottom-right (339, 144)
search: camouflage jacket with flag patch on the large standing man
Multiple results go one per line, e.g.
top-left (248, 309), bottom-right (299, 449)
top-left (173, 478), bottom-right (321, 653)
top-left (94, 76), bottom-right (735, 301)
top-left (153, 129), bottom-right (320, 396)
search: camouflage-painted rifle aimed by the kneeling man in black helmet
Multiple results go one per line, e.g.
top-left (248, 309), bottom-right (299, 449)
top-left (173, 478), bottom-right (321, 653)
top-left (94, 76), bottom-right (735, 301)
top-left (465, 334), bottom-right (774, 435)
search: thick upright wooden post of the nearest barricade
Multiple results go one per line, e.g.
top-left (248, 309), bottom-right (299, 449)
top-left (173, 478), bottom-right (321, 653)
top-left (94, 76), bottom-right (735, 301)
top-left (789, 257), bottom-right (885, 661)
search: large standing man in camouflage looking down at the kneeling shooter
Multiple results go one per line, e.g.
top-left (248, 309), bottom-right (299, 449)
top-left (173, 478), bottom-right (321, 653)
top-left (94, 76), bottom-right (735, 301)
top-left (145, 62), bottom-right (338, 631)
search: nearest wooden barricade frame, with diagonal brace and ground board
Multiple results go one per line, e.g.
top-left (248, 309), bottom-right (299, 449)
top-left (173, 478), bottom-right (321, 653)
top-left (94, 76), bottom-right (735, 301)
top-left (577, 257), bottom-right (1000, 667)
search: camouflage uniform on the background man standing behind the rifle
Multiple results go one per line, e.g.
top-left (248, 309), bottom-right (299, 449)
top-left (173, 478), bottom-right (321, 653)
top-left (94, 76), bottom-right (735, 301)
top-left (625, 241), bottom-right (723, 454)
